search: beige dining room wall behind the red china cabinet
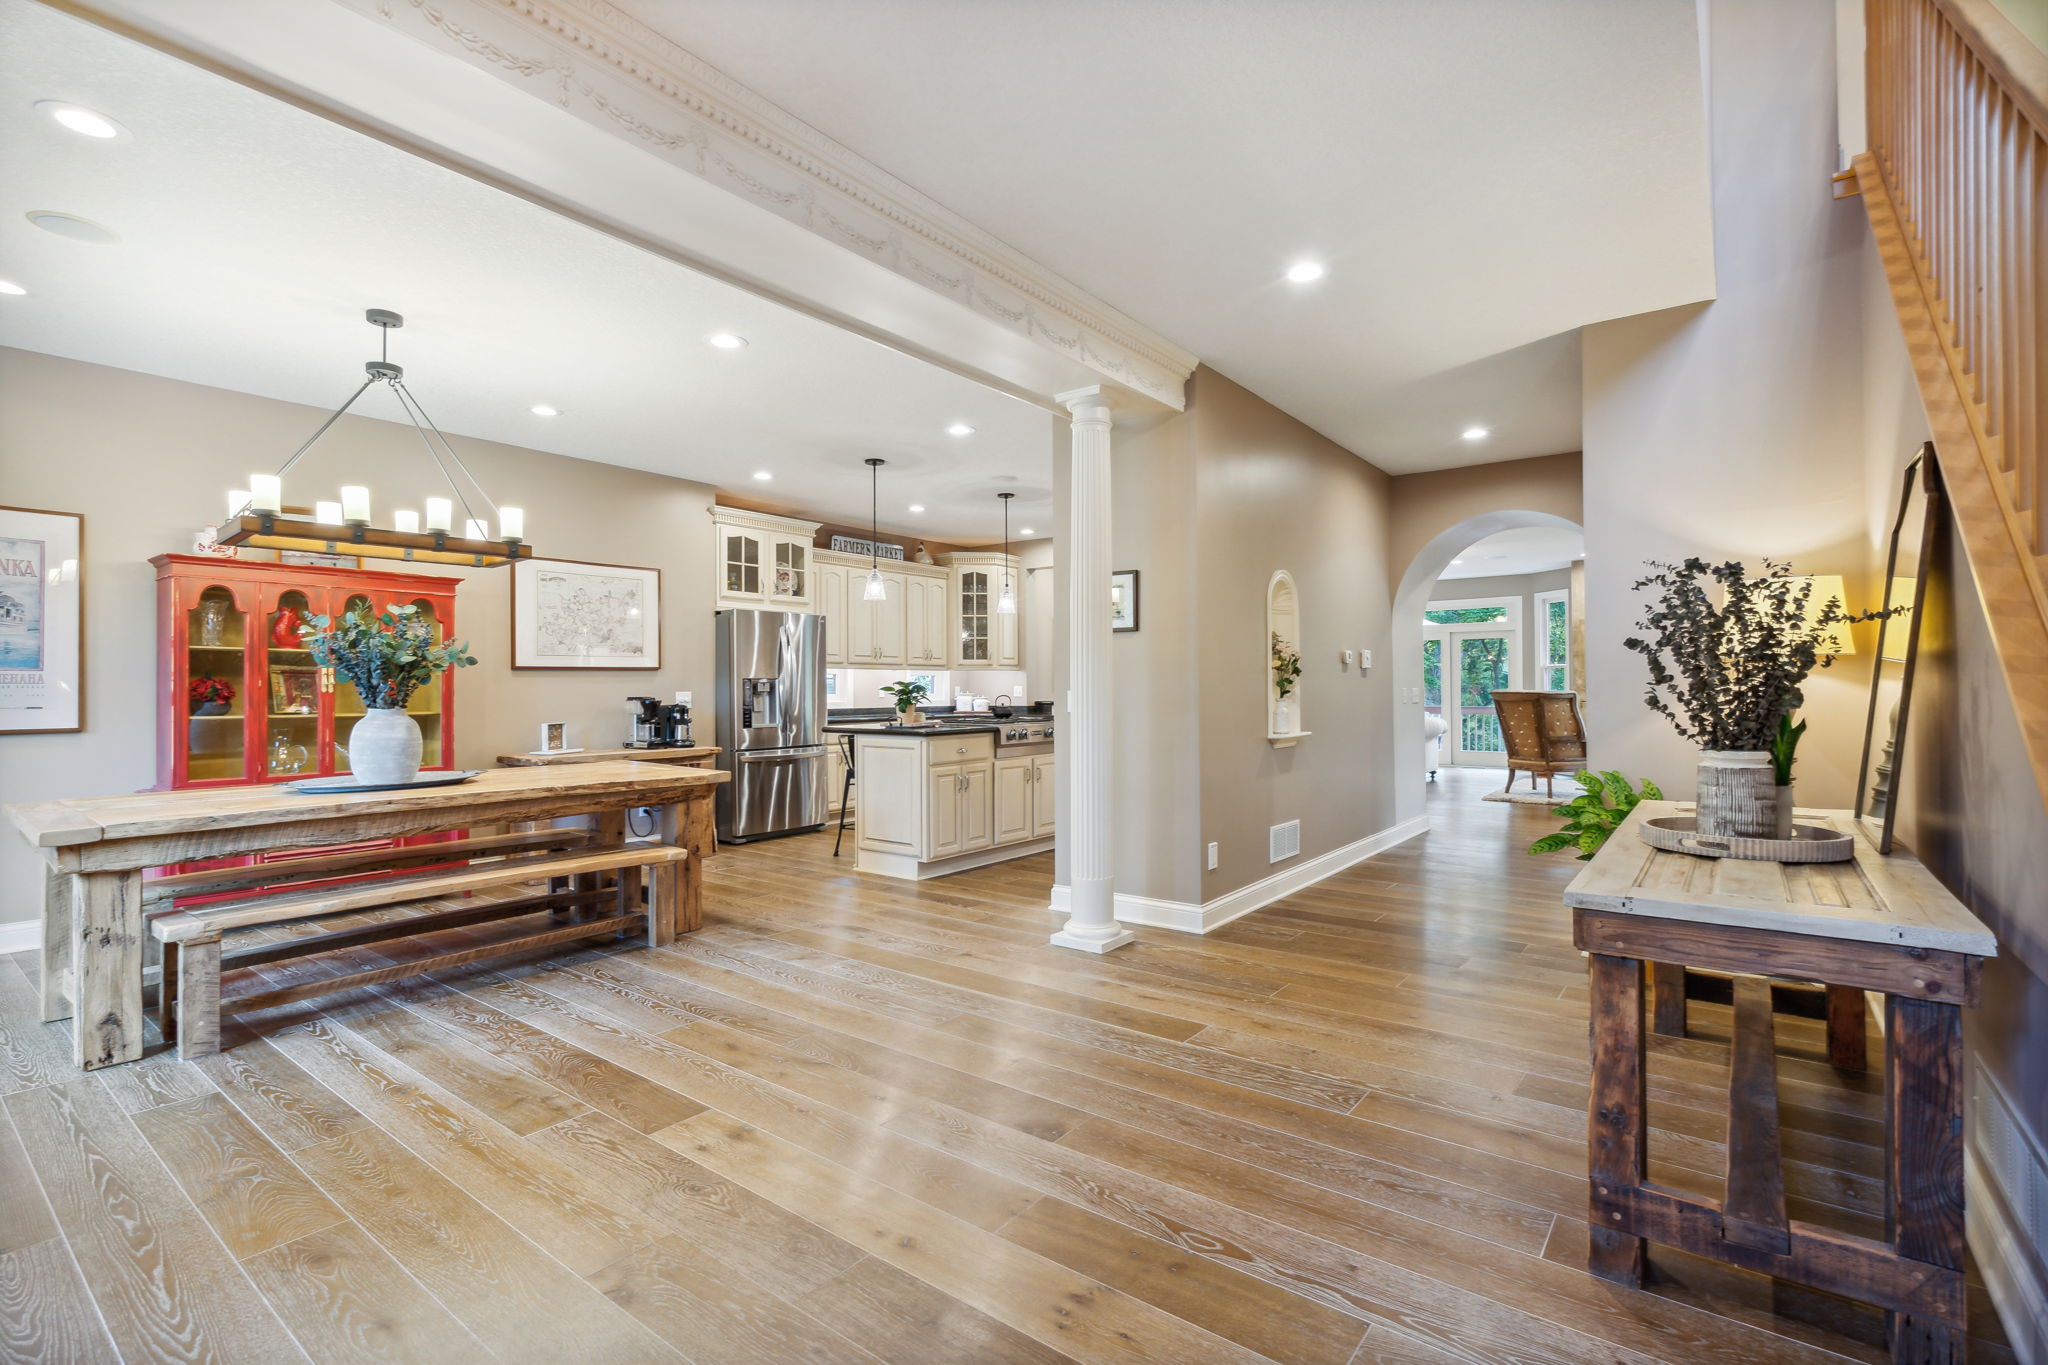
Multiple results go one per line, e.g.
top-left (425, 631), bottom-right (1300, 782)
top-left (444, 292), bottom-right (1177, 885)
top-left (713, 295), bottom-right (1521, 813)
top-left (0, 350), bottom-right (713, 923)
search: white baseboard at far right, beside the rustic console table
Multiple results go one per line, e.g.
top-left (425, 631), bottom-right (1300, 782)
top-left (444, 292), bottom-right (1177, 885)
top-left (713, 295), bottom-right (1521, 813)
top-left (1964, 1060), bottom-right (2048, 1365)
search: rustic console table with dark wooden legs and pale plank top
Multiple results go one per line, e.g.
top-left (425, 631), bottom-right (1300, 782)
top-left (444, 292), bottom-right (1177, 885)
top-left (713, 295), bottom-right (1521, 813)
top-left (1565, 802), bottom-right (1997, 1363)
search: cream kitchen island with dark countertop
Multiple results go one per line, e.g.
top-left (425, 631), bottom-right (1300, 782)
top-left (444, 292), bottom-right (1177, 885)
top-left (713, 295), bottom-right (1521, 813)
top-left (825, 714), bottom-right (1057, 880)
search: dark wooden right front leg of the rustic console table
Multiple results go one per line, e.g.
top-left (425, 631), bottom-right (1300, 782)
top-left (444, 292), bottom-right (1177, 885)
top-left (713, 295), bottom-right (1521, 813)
top-left (1884, 995), bottom-right (1964, 1365)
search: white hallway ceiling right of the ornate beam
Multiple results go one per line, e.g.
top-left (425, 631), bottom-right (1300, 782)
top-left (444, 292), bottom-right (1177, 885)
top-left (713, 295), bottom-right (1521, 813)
top-left (616, 0), bottom-right (1712, 473)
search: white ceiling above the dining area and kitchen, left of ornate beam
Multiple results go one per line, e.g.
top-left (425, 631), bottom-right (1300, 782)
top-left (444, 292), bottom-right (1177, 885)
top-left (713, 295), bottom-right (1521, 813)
top-left (0, 0), bottom-right (1053, 542)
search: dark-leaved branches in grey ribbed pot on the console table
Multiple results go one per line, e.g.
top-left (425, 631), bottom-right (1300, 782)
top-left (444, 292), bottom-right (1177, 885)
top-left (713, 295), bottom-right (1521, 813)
top-left (1622, 559), bottom-right (1896, 839)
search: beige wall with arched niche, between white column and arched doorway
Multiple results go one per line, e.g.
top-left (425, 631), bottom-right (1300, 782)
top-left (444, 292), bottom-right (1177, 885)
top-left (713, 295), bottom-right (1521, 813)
top-left (1178, 368), bottom-right (1393, 900)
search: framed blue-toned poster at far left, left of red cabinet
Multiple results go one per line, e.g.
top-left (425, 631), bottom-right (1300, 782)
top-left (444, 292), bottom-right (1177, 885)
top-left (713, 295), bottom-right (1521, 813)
top-left (0, 508), bottom-right (86, 735)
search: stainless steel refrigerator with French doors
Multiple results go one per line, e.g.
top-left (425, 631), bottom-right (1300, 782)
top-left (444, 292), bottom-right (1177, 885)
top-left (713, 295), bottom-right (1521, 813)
top-left (715, 612), bottom-right (829, 843)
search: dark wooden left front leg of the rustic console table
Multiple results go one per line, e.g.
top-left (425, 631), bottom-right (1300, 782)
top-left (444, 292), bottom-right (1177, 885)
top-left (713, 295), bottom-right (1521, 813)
top-left (1585, 954), bottom-right (1649, 1285)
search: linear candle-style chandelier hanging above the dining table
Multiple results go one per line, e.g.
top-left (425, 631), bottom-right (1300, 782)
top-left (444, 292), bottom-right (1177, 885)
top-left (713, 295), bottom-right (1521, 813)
top-left (219, 309), bottom-right (532, 569)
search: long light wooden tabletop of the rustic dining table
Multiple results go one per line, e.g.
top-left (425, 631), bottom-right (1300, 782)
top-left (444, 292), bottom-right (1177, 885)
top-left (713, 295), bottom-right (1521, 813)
top-left (6, 761), bottom-right (727, 847)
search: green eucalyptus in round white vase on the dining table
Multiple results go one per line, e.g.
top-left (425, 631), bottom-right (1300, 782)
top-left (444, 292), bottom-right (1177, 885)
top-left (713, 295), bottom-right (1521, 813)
top-left (305, 606), bottom-right (477, 786)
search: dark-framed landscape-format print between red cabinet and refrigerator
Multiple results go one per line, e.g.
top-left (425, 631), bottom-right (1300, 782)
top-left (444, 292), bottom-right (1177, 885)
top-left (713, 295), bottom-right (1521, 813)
top-left (512, 559), bottom-right (662, 669)
